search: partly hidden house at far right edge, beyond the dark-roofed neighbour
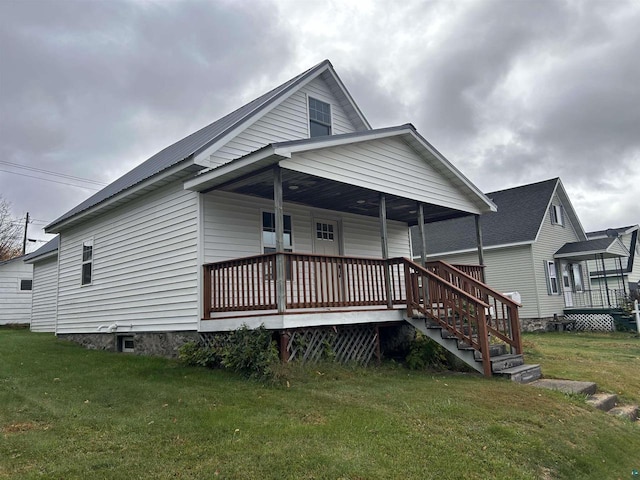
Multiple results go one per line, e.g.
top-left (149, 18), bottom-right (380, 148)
top-left (587, 225), bottom-right (640, 296)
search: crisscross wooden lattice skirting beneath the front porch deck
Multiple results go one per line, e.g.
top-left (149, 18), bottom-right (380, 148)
top-left (285, 325), bottom-right (380, 365)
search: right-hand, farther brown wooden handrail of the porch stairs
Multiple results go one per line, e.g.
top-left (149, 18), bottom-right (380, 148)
top-left (427, 260), bottom-right (523, 354)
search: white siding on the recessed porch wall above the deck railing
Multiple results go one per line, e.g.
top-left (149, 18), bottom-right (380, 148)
top-left (203, 192), bottom-right (410, 263)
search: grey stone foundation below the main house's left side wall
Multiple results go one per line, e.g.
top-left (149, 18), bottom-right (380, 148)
top-left (58, 332), bottom-right (198, 358)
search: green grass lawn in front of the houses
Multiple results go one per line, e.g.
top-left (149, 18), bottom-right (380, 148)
top-left (0, 329), bottom-right (640, 480)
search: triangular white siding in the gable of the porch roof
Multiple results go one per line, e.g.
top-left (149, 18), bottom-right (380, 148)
top-left (280, 134), bottom-right (478, 213)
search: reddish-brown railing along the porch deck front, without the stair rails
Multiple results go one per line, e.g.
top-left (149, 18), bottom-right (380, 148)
top-left (204, 253), bottom-right (406, 319)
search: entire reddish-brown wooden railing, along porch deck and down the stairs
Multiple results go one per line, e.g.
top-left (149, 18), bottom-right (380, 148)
top-left (203, 253), bottom-right (522, 374)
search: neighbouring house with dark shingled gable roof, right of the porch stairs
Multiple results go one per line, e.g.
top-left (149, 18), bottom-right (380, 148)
top-left (412, 178), bottom-right (628, 329)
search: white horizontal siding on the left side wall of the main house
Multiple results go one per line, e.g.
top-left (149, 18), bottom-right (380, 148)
top-left (57, 182), bottom-right (199, 333)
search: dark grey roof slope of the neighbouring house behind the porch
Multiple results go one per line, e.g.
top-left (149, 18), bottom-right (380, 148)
top-left (411, 178), bottom-right (560, 256)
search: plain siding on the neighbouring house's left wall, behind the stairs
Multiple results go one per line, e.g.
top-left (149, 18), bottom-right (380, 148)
top-left (427, 245), bottom-right (546, 318)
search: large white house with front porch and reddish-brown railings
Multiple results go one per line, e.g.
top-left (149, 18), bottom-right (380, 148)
top-left (43, 61), bottom-right (521, 375)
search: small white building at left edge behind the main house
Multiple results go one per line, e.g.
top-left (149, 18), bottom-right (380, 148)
top-left (0, 256), bottom-right (33, 325)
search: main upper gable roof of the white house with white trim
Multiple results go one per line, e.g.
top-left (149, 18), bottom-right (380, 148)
top-left (45, 60), bottom-right (371, 233)
